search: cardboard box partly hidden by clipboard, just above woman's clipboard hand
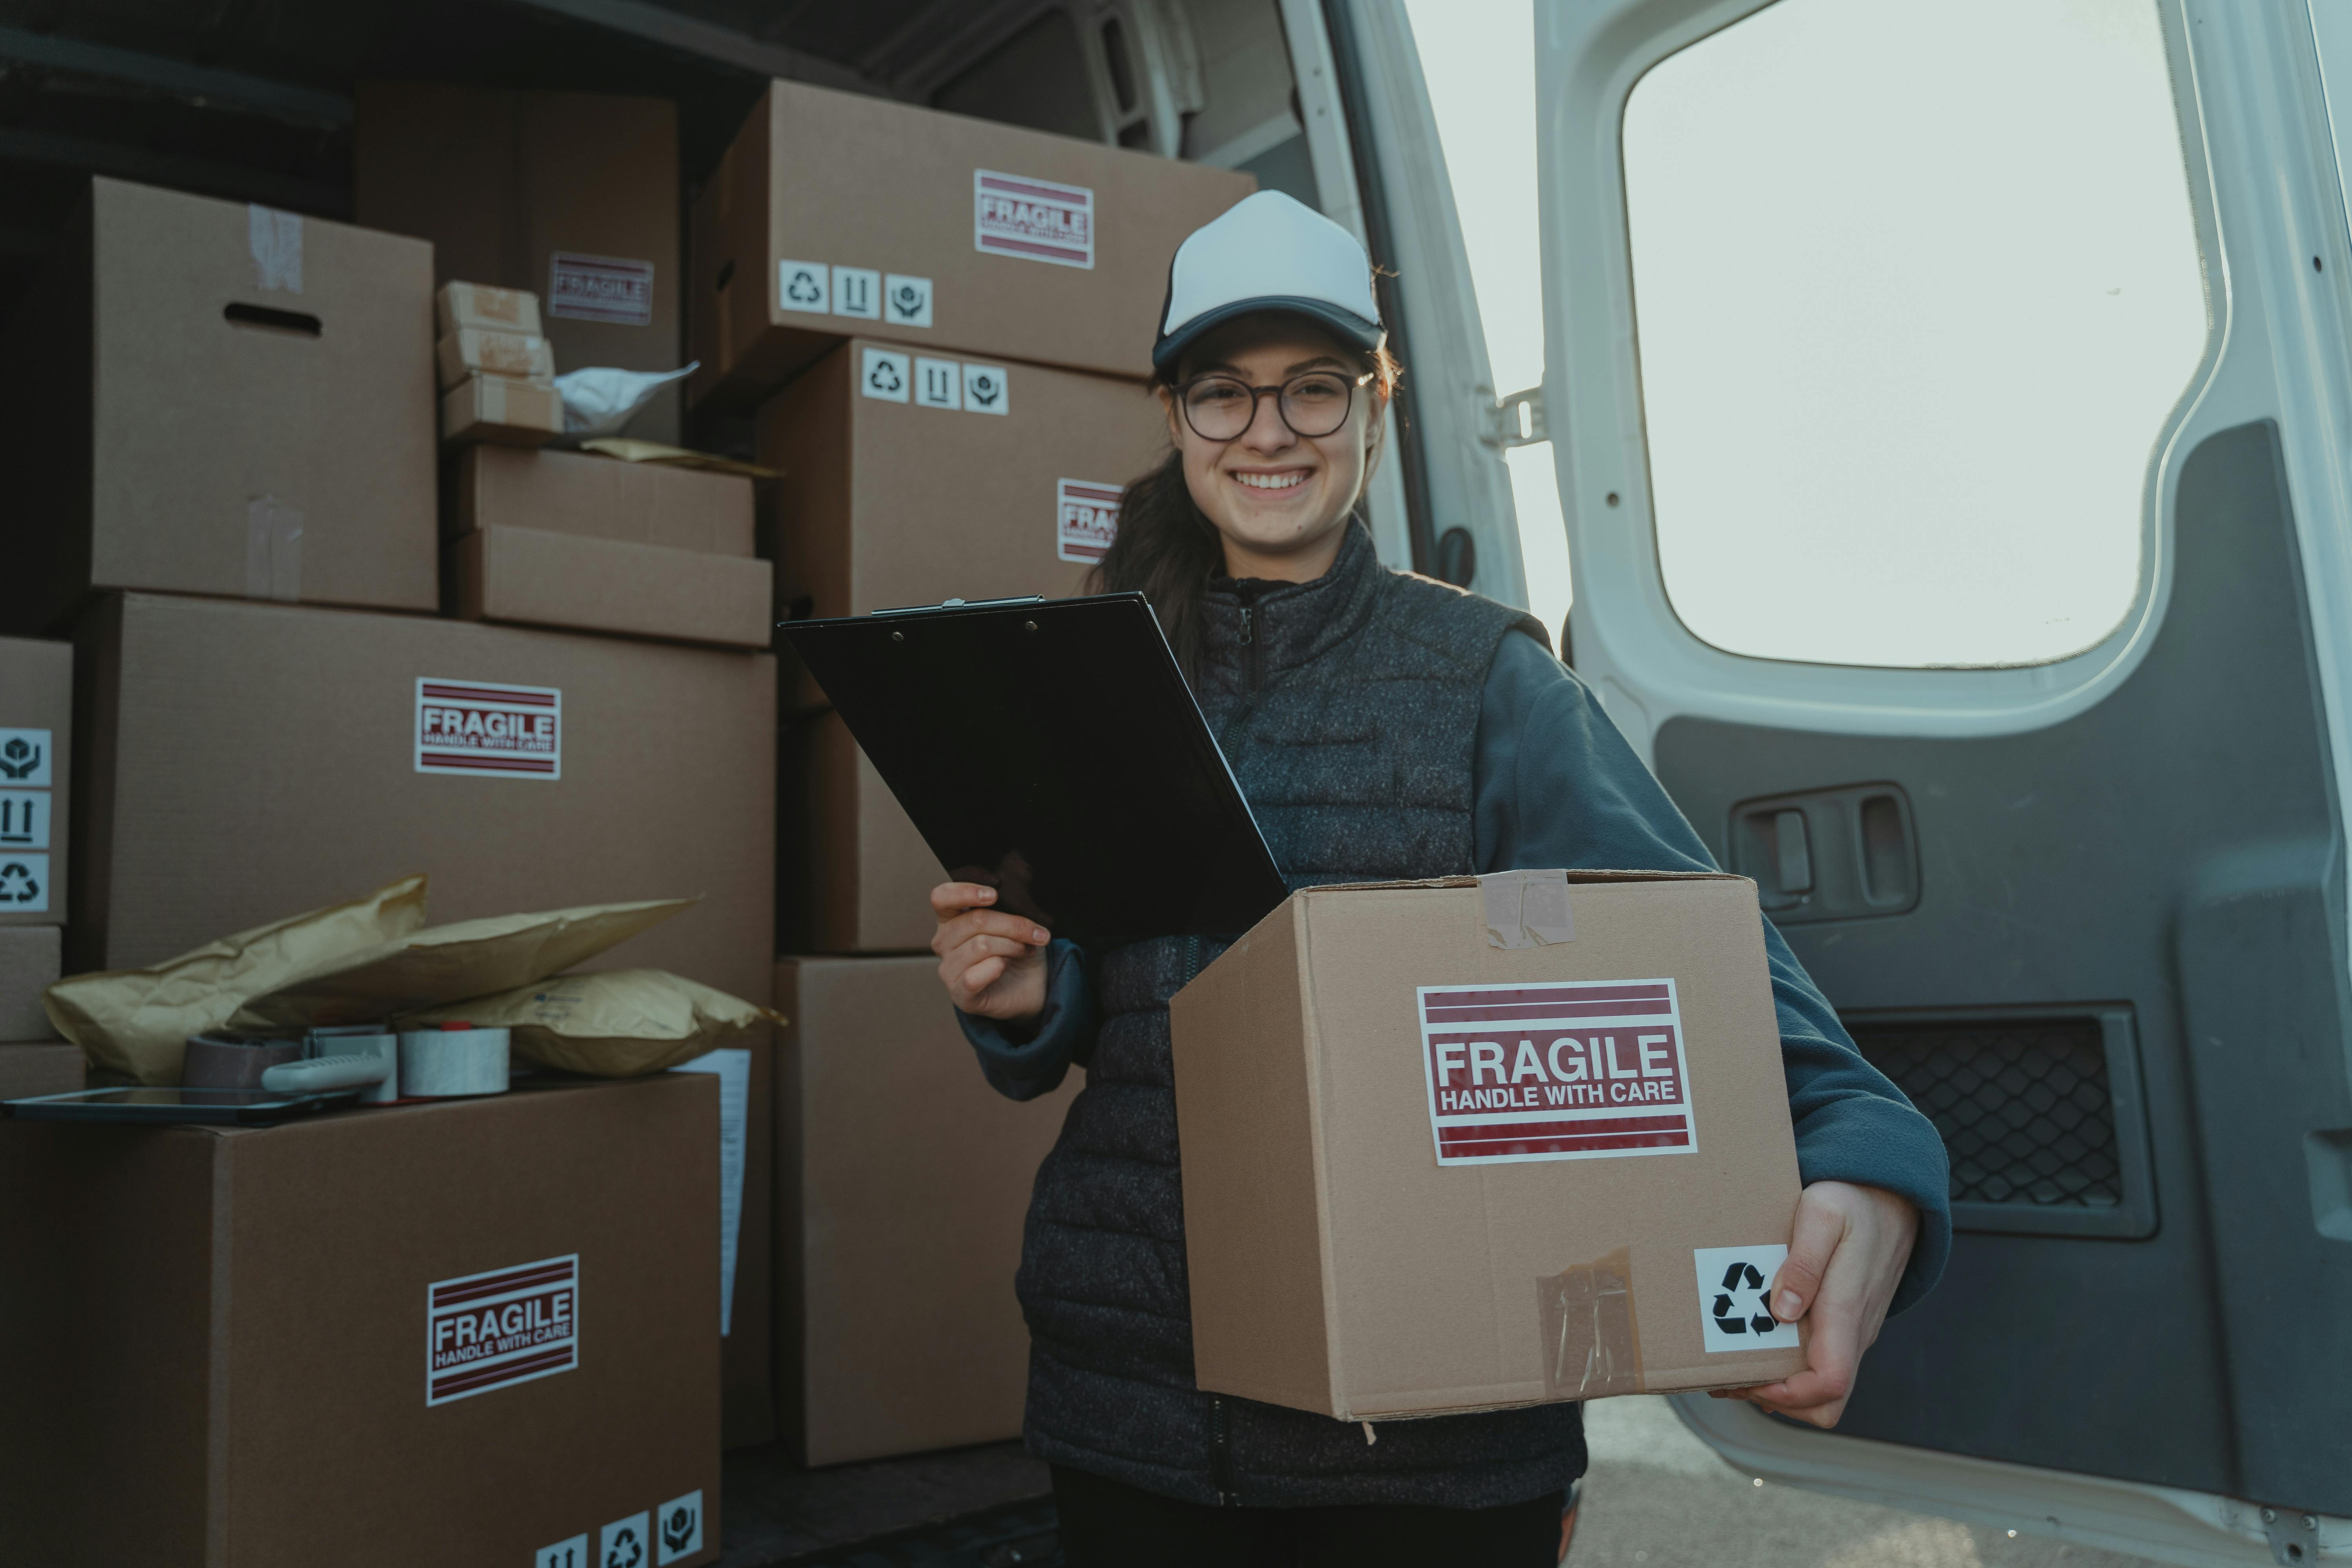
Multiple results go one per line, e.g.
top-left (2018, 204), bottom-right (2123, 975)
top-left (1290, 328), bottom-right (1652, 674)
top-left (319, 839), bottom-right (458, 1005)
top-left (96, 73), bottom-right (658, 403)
top-left (776, 708), bottom-right (948, 952)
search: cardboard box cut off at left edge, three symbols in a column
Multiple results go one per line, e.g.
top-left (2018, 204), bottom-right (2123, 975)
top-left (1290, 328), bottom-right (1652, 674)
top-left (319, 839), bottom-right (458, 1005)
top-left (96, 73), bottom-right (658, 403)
top-left (0, 635), bottom-right (73, 926)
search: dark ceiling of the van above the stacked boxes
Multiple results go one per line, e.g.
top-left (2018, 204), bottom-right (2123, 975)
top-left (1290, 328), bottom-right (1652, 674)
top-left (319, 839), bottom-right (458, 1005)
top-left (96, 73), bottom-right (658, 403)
top-left (0, 0), bottom-right (1270, 320)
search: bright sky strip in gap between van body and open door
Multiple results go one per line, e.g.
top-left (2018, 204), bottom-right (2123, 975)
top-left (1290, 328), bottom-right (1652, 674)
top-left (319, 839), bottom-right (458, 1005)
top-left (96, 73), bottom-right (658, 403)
top-left (1404, 0), bottom-right (1569, 637)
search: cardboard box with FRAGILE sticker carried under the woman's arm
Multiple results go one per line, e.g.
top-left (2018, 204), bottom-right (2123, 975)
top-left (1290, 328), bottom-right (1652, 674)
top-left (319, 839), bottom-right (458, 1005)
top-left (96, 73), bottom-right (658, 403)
top-left (1169, 872), bottom-right (1804, 1420)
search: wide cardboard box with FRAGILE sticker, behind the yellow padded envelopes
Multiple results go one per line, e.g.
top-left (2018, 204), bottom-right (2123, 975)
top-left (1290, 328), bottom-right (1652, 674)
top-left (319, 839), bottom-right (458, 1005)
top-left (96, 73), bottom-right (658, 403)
top-left (68, 595), bottom-right (776, 1002)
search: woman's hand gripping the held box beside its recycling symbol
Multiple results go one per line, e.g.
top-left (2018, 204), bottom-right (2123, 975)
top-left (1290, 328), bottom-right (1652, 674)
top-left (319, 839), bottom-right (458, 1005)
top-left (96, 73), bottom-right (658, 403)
top-left (1712, 1182), bottom-right (1919, 1427)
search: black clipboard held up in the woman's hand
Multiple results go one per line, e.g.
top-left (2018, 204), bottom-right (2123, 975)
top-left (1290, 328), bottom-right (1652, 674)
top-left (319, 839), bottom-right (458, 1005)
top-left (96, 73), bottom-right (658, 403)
top-left (781, 592), bottom-right (1289, 945)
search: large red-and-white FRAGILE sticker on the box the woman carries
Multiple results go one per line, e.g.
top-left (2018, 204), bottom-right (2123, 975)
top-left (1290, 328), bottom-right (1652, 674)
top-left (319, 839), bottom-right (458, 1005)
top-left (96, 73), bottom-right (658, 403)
top-left (1418, 980), bottom-right (1698, 1166)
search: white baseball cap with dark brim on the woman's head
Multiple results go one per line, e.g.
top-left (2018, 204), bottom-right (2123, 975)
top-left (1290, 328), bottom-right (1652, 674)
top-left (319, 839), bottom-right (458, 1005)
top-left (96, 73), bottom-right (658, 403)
top-left (1152, 191), bottom-right (1388, 374)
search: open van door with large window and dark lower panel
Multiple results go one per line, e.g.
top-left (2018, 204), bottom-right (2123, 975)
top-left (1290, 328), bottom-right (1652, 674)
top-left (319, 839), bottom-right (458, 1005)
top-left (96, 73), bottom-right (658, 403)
top-left (1534, 0), bottom-right (2352, 1563)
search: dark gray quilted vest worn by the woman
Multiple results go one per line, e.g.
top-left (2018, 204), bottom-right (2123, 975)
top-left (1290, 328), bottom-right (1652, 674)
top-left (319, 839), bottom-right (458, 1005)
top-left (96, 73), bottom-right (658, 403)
top-left (1018, 526), bottom-right (1585, 1507)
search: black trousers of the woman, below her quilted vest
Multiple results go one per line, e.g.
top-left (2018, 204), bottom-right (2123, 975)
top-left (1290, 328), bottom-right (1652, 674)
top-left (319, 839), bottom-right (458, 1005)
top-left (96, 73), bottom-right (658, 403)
top-left (1054, 1465), bottom-right (1566, 1568)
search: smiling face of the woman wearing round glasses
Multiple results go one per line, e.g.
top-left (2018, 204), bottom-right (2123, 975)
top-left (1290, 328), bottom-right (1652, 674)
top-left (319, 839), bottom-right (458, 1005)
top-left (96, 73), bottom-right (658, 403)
top-left (1162, 315), bottom-right (1388, 583)
